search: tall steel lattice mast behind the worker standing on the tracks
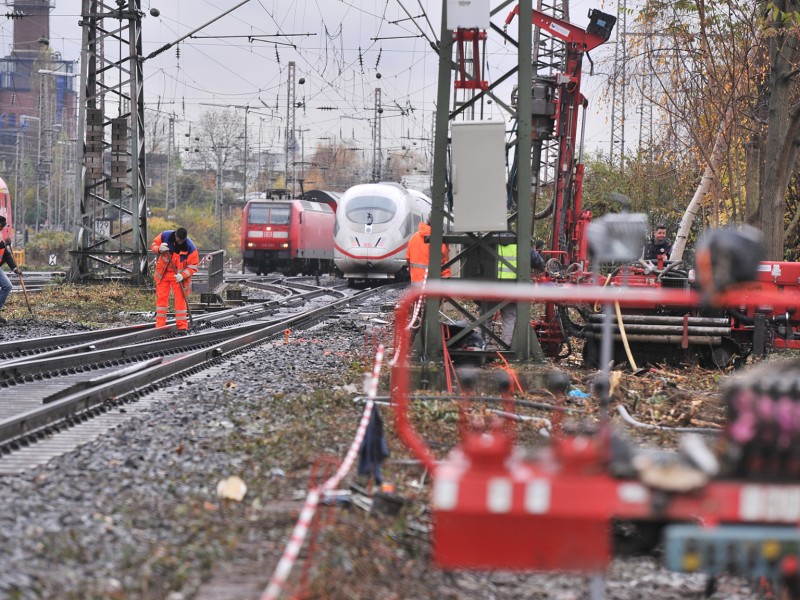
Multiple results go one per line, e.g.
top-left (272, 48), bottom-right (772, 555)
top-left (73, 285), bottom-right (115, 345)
top-left (69, 0), bottom-right (148, 283)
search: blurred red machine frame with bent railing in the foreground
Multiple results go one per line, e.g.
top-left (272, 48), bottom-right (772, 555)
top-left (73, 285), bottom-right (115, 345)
top-left (391, 281), bottom-right (800, 573)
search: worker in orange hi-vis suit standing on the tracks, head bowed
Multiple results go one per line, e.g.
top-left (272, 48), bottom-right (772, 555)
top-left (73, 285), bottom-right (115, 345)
top-left (150, 227), bottom-right (200, 335)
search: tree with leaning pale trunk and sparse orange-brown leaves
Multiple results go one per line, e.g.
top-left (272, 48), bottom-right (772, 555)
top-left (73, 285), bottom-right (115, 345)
top-left (631, 0), bottom-right (760, 259)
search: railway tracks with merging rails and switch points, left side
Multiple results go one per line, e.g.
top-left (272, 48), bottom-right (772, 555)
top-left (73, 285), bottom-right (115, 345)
top-left (0, 281), bottom-right (396, 475)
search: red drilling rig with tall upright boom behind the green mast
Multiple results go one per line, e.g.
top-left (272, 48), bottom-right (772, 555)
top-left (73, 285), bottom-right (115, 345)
top-left (506, 7), bottom-right (800, 367)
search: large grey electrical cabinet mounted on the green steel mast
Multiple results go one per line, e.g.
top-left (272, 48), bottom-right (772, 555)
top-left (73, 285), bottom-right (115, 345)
top-left (450, 121), bottom-right (508, 233)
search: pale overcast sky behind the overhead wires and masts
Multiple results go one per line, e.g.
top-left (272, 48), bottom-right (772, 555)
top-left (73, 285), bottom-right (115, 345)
top-left (6, 0), bottom-right (616, 163)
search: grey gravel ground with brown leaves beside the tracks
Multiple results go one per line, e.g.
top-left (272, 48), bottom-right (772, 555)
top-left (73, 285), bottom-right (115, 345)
top-left (0, 293), bottom-right (756, 600)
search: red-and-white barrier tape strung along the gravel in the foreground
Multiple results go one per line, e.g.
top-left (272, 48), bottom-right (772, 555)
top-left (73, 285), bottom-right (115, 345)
top-left (261, 344), bottom-right (384, 600)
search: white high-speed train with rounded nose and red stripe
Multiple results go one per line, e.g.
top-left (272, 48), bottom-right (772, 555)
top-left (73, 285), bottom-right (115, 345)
top-left (333, 182), bottom-right (431, 281)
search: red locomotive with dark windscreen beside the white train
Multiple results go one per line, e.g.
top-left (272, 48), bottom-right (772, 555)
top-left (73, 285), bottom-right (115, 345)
top-left (241, 199), bottom-right (334, 275)
